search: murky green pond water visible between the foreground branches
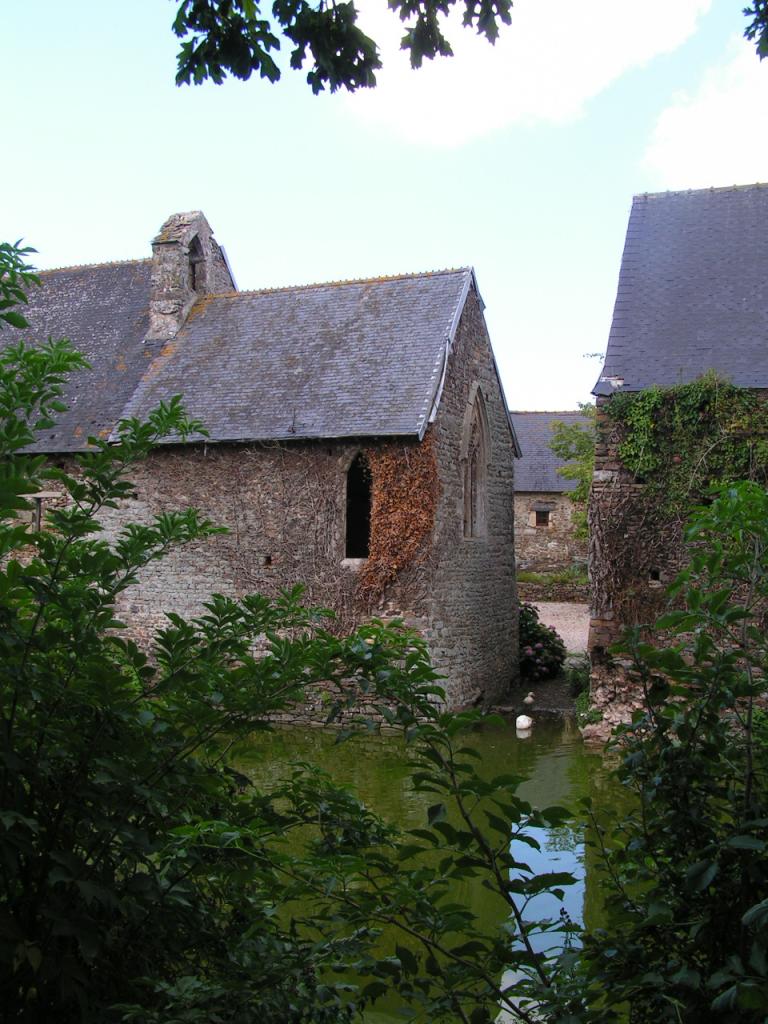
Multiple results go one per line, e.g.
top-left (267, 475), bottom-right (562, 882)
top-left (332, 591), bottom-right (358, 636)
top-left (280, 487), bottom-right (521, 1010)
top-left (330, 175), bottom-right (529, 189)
top-left (238, 717), bottom-right (622, 1024)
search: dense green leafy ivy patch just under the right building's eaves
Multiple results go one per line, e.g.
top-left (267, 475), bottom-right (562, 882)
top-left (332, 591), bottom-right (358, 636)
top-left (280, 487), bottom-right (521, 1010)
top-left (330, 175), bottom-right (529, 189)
top-left (606, 373), bottom-right (768, 520)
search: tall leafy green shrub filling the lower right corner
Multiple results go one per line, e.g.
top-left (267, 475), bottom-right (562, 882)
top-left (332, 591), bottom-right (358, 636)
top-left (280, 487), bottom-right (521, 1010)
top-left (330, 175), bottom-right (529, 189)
top-left (565, 482), bottom-right (768, 1024)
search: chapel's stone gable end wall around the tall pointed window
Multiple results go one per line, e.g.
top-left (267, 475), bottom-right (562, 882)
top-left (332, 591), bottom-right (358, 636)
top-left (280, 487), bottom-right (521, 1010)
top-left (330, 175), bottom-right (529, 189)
top-left (429, 284), bottom-right (517, 703)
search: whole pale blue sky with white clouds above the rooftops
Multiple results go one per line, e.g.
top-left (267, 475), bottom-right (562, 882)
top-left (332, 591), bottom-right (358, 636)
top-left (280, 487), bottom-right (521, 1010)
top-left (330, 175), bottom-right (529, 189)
top-left (0, 0), bottom-right (768, 409)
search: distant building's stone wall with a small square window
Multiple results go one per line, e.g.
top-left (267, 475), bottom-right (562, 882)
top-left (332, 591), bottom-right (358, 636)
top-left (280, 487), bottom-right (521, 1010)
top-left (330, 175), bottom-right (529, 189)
top-left (515, 492), bottom-right (588, 572)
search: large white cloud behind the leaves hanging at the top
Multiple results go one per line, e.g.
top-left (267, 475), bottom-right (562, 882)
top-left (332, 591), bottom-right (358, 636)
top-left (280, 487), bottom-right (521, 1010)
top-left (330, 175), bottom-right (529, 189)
top-left (347, 0), bottom-right (711, 146)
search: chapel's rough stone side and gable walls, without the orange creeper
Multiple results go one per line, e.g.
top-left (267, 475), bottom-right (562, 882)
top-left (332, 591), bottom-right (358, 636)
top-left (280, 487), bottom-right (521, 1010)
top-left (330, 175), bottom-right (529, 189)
top-left (93, 380), bottom-right (517, 720)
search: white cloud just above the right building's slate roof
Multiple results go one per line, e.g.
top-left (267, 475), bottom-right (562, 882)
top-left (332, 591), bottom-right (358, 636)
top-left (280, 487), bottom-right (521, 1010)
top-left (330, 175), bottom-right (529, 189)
top-left (644, 40), bottom-right (768, 189)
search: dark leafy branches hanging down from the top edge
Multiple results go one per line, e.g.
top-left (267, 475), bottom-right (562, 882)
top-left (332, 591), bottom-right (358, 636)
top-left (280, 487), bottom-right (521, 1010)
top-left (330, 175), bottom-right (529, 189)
top-left (173, 0), bottom-right (768, 93)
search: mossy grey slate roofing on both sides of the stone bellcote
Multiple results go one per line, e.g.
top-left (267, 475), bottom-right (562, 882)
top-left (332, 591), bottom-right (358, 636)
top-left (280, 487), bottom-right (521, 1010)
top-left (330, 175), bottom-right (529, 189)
top-left (17, 260), bottom-right (473, 452)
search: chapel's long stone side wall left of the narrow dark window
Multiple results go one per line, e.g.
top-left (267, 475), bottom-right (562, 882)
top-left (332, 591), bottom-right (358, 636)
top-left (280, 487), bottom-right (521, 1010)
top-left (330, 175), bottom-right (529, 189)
top-left (96, 441), bottom-right (426, 618)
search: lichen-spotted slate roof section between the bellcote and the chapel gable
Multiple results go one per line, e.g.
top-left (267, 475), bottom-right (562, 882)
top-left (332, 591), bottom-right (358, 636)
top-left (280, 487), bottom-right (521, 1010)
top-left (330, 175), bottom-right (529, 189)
top-left (120, 269), bottom-right (473, 440)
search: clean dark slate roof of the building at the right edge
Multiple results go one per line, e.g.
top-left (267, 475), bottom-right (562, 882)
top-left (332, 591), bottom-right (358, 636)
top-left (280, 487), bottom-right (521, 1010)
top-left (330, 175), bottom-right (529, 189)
top-left (594, 184), bottom-right (768, 394)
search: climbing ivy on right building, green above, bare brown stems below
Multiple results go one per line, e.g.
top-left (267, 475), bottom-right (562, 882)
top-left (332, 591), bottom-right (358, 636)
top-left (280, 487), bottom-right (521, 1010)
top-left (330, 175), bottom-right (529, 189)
top-left (590, 373), bottom-right (768, 624)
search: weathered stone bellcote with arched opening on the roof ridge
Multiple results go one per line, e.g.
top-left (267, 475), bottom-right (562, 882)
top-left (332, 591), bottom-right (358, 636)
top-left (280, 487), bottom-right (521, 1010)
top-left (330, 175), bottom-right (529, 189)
top-left (146, 210), bottom-right (237, 341)
